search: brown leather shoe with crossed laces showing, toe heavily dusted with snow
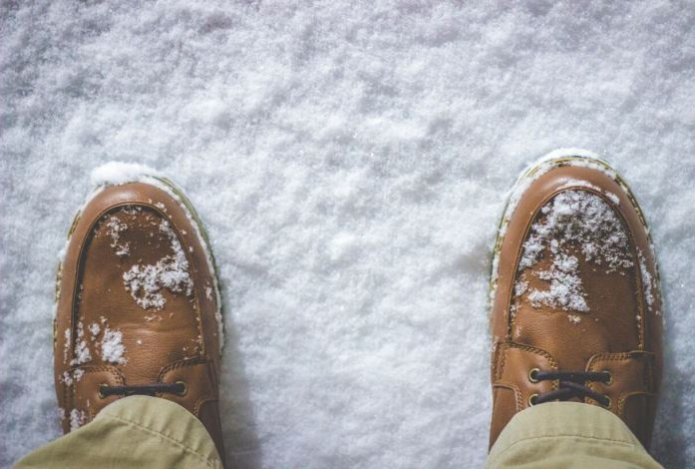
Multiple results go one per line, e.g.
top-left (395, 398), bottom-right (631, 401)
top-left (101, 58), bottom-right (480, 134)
top-left (490, 151), bottom-right (663, 448)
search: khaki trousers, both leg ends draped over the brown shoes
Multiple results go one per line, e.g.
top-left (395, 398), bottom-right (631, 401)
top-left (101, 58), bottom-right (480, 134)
top-left (15, 396), bottom-right (661, 469)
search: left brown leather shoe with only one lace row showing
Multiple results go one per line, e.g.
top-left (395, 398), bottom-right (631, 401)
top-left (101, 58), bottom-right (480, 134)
top-left (54, 169), bottom-right (224, 457)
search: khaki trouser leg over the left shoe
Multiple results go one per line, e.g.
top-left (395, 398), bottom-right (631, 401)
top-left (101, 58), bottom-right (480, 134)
top-left (15, 396), bottom-right (222, 469)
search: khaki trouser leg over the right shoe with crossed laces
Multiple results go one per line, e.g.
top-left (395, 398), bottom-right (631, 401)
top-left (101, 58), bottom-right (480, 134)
top-left (486, 402), bottom-right (661, 469)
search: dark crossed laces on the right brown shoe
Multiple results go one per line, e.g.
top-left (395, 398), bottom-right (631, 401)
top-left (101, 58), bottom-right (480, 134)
top-left (529, 369), bottom-right (612, 407)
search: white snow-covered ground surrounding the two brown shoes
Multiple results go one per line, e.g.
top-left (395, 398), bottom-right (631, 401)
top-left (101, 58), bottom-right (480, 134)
top-left (0, 0), bottom-right (695, 468)
